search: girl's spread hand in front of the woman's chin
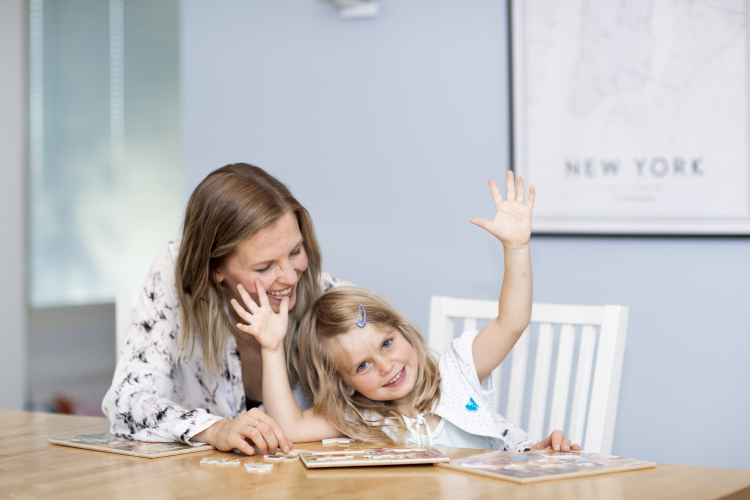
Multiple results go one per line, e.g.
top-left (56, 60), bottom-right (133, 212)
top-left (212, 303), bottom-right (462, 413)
top-left (232, 279), bottom-right (289, 351)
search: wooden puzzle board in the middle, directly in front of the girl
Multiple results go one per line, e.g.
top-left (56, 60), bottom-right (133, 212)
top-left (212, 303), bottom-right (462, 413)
top-left (300, 448), bottom-right (450, 469)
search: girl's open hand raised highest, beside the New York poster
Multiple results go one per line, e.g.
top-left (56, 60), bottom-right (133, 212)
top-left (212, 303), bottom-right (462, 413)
top-left (470, 170), bottom-right (536, 246)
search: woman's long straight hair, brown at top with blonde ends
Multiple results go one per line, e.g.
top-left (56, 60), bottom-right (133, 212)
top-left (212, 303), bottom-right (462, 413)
top-left (175, 163), bottom-right (321, 385)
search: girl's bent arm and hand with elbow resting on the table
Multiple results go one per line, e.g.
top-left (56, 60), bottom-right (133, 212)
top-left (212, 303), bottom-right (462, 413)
top-left (232, 280), bottom-right (341, 442)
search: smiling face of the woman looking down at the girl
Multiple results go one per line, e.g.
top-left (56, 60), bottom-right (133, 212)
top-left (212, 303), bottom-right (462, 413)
top-left (216, 212), bottom-right (307, 312)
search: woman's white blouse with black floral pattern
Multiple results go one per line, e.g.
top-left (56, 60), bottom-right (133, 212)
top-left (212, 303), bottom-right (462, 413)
top-left (102, 241), bottom-right (350, 445)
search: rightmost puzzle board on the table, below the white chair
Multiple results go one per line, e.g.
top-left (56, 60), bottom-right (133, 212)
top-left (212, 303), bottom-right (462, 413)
top-left (438, 450), bottom-right (656, 484)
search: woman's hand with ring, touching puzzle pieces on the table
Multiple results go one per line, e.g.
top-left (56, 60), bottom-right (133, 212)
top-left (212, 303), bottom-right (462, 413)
top-left (190, 408), bottom-right (294, 455)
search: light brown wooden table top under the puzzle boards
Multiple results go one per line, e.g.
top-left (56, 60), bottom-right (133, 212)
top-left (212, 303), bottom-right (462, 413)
top-left (0, 411), bottom-right (750, 500)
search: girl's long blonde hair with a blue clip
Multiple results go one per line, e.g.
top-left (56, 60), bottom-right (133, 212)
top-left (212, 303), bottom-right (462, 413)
top-left (298, 286), bottom-right (440, 444)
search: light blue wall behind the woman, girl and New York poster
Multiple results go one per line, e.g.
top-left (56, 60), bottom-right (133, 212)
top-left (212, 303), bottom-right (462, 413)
top-left (182, 0), bottom-right (750, 468)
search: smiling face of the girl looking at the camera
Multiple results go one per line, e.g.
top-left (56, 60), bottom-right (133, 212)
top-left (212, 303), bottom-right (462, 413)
top-left (336, 323), bottom-right (418, 408)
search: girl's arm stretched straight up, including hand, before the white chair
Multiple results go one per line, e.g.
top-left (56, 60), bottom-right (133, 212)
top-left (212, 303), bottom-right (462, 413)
top-left (471, 171), bottom-right (535, 380)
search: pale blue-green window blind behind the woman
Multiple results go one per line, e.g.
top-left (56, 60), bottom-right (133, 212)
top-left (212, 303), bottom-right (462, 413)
top-left (29, 0), bottom-right (184, 307)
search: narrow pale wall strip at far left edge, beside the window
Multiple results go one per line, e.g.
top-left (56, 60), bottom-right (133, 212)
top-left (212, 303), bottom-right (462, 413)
top-left (0, 0), bottom-right (28, 410)
